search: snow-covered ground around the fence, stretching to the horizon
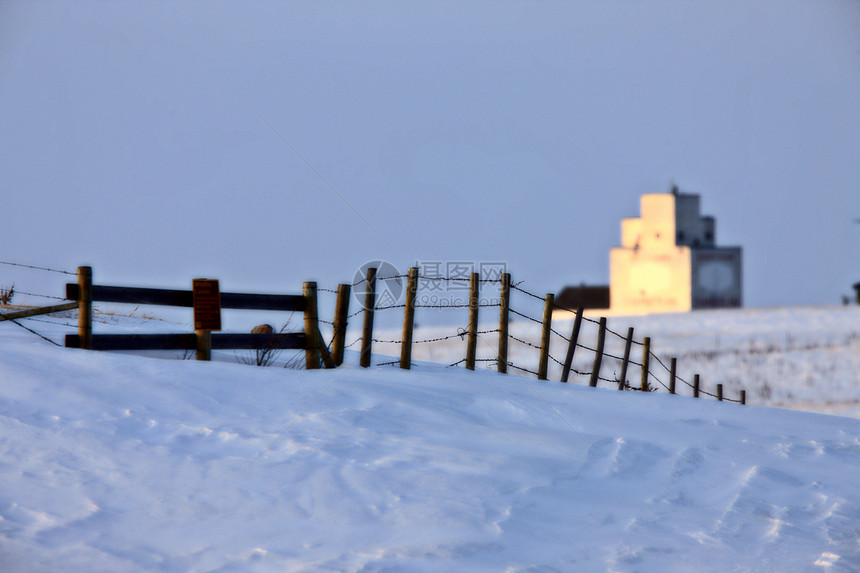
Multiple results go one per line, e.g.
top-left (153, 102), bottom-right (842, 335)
top-left (0, 307), bottom-right (860, 573)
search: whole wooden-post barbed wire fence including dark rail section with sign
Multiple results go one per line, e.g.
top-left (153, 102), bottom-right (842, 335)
top-left (0, 267), bottom-right (746, 404)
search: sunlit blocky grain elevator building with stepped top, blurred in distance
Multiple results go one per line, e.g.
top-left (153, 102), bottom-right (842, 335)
top-left (609, 187), bottom-right (742, 314)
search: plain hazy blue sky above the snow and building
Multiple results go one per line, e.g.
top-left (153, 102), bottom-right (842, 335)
top-left (0, 0), bottom-right (860, 312)
